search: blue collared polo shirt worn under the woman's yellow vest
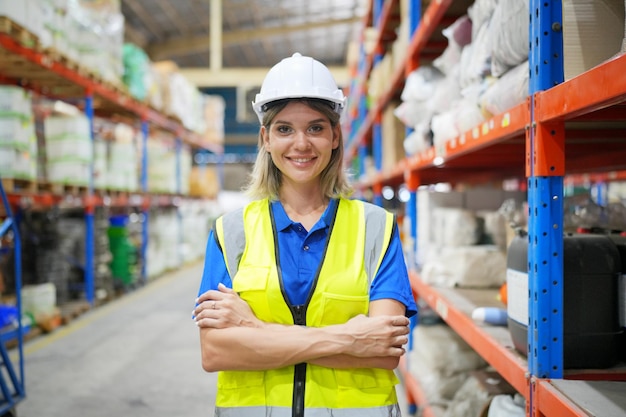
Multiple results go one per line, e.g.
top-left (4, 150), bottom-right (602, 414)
top-left (198, 199), bottom-right (417, 317)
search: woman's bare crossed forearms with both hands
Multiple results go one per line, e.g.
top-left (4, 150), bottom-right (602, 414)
top-left (194, 285), bottom-right (409, 372)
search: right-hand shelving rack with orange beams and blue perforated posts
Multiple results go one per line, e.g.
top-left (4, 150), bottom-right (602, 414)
top-left (345, 0), bottom-right (626, 416)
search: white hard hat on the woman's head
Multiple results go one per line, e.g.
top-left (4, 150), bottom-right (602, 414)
top-left (252, 52), bottom-right (346, 123)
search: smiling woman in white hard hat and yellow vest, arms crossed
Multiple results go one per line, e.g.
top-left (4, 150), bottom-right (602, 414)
top-left (194, 54), bottom-right (416, 417)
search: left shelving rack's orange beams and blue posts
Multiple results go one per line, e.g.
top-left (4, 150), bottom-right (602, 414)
top-left (0, 16), bottom-right (223, 305)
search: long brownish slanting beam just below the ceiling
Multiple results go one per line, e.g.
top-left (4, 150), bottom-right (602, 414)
top-left (146, 17), bottom-right (361, 61)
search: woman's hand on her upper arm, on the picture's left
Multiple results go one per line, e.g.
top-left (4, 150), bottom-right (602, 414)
top-left (193, 284), bottom-right (263, 329)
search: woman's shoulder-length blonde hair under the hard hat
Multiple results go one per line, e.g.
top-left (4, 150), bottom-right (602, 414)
top-left (244, 98), bottom-right (353, 200)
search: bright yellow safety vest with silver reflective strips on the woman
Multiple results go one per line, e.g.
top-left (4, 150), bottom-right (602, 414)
top-left (215, 199), bottom-right (400, 417)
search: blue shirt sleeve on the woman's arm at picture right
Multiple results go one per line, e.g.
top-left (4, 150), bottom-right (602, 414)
top-left (370, 225), bottom-right (417, 317)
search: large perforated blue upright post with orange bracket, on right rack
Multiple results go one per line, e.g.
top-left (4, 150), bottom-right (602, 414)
top-left (527, 0), bottom-right (565, 378)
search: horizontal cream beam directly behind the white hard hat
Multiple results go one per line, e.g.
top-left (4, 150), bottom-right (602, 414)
top-left (179, 67), bottom-right (350, 88)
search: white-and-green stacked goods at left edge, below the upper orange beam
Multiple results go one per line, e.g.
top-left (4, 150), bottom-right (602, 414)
top-left (0, 86), bottom-right (37, 180)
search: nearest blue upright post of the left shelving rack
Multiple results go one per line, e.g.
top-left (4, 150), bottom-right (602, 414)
top-left (85, 91), bottom-right (96, 306)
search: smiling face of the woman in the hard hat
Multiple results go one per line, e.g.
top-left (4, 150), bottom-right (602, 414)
top-left (261, 102), bottom-right (340, 185)
